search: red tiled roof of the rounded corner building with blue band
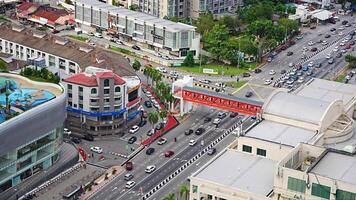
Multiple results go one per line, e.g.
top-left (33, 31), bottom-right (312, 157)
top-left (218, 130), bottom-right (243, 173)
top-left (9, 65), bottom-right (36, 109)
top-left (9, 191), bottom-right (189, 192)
top-left (64, 72), bottom-right (125, 87)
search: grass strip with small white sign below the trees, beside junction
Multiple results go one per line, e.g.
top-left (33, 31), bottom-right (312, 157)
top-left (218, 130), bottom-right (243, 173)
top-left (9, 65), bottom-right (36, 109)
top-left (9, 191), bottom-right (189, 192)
top-left (177, 63), bottom-right (257, 76)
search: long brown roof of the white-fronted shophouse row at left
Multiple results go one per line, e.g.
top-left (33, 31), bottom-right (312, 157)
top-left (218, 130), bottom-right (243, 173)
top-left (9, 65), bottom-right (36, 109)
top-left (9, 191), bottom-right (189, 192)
top-left (0, 23), bottom-right (135, 76)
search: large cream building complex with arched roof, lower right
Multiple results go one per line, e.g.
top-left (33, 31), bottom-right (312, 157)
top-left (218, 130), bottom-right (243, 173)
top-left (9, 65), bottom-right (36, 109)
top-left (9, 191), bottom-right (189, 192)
top-left (190, 79), bottom-right (356, 200)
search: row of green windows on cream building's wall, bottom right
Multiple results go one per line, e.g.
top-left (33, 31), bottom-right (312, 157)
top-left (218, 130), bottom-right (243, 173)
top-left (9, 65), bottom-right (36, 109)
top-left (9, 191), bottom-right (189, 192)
top-left (287, 177), bottom-right (356, 200)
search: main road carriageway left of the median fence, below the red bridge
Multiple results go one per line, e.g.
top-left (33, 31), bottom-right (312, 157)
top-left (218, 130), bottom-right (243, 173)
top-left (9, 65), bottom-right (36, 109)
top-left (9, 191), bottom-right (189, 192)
top-left (90, 107), bottom-right (250, 200)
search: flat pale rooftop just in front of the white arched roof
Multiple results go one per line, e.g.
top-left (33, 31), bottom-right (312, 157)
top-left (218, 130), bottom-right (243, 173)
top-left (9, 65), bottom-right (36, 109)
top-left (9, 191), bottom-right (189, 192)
top-left (245, 120), bottom-right (316, 147)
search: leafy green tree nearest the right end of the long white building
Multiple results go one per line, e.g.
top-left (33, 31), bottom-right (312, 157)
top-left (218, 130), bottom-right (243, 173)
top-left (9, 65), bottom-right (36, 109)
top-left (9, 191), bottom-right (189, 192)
top-left (205, 24), bottom-right (229, 61)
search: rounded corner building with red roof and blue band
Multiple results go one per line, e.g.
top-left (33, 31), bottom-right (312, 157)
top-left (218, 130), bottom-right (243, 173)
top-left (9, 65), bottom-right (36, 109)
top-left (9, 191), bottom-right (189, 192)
top-left (63, 67), bottom-right (140, 137)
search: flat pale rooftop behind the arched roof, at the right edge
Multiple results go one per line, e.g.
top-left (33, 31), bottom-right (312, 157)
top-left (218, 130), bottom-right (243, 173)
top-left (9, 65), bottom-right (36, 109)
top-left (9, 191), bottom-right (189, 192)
top-left (297, 79), bottom-right (356, 107)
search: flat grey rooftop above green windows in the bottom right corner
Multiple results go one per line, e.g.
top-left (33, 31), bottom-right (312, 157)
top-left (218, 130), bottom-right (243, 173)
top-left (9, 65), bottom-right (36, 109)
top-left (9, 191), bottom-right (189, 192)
top-left (311, 151), bottom-right (356, 185)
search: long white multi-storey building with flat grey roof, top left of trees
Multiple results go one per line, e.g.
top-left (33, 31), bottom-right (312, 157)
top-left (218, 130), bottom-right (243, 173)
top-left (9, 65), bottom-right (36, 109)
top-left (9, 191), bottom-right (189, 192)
top-left (75, 0), bottom-right (200, 58)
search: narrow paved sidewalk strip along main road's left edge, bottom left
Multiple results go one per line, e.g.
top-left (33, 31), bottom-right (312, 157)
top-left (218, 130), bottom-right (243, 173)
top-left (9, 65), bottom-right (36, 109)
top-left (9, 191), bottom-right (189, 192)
top-left (79, 166), bottom-right (124, 200)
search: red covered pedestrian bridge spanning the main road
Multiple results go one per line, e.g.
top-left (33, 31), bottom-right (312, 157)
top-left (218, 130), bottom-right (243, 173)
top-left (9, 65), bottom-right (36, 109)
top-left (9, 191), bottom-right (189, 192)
top-left (173, 86), bottom-right (263, 116)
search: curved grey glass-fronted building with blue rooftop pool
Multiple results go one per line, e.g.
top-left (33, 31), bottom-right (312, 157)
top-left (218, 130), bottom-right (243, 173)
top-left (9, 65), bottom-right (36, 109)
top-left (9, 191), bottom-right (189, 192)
top-left (0, 73), bottom-right (66, 193)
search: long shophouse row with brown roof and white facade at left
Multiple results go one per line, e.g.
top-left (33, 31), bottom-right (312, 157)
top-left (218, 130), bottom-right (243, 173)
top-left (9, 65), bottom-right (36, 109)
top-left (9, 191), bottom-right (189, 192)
top-left (0, 23), bottom-right (135, 77)
